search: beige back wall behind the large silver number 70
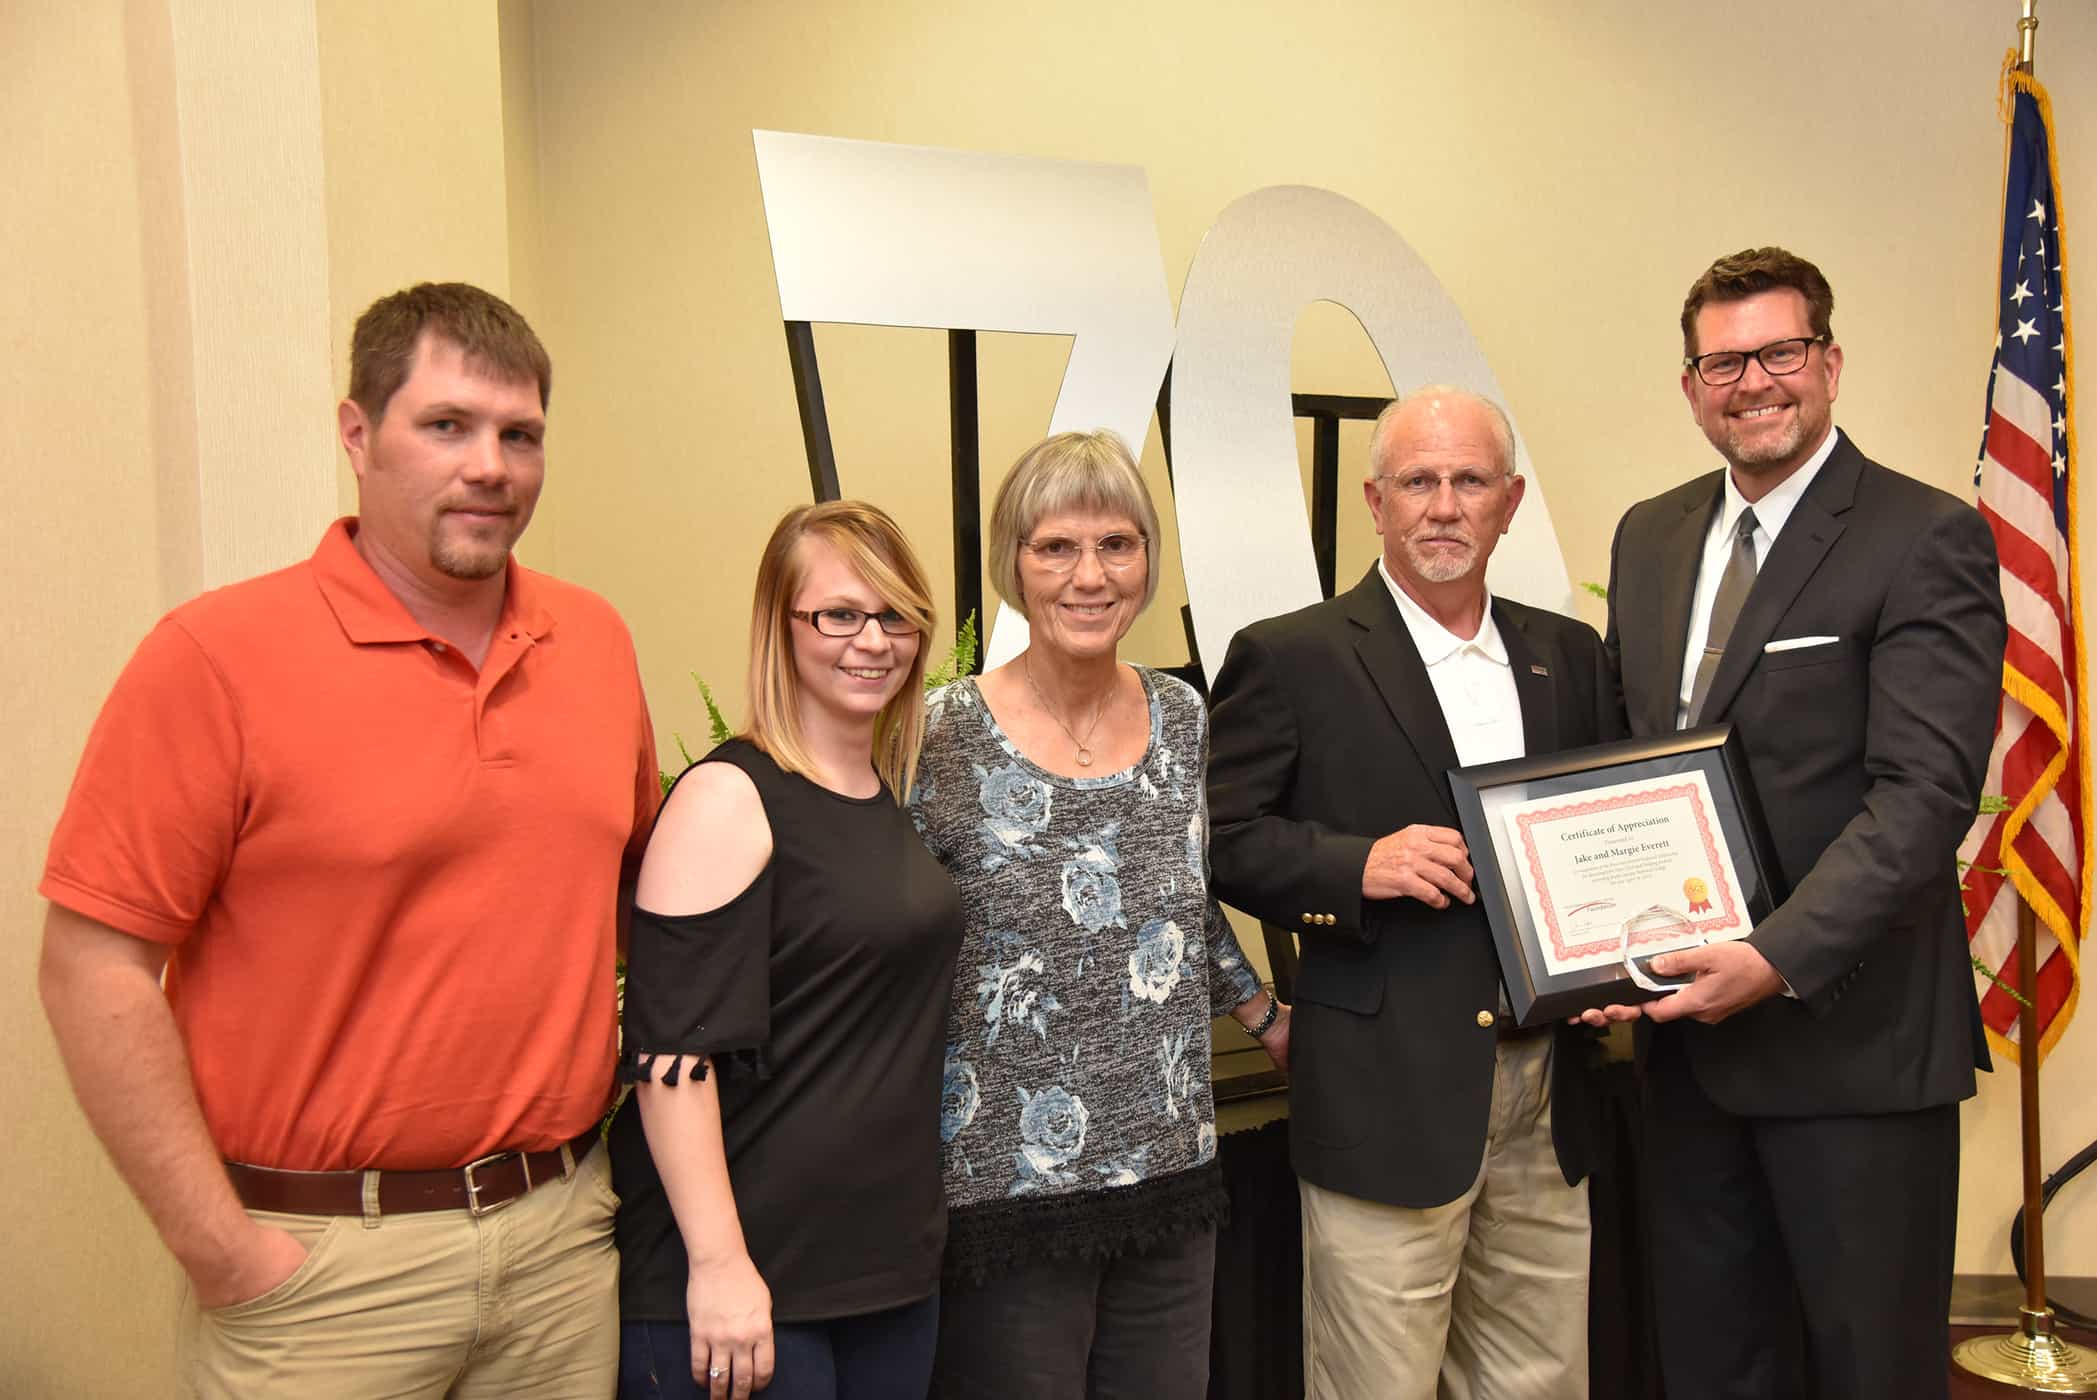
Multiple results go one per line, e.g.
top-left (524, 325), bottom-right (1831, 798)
top-left (520, 0), bottom-right (2097, 1274)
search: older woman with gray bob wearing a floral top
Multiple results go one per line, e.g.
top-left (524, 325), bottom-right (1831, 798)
top-left (912, 432), bottom-right (1288, 1400)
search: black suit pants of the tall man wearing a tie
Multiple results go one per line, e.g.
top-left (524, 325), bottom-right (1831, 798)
top-left (1644, 1027), bottom-right (1959, 1400)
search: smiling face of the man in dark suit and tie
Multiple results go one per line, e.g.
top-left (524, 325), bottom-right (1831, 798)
top-left (1682, 287), bottom-right (1841, 499)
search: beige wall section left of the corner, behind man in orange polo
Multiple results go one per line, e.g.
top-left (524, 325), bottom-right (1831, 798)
top-left (0, 0), bottom-right (510, 1398)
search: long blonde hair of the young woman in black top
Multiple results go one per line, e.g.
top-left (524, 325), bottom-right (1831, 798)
top-left (744, 501), bottom-right (937, 803)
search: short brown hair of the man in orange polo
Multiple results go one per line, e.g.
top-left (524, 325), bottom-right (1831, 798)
top-left (350, 283), bottom-right (554, 423)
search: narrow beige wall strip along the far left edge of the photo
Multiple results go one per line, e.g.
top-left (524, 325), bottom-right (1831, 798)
top-left (0, 4), bottom-right (174, 1396)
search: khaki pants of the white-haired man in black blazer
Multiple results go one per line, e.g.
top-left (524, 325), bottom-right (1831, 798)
top-left (1298, 1035), bottom-right (1587, 1400)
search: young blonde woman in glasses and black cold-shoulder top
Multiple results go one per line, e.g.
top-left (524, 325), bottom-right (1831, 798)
top-left (612, 501), bottom-right (960, 1400)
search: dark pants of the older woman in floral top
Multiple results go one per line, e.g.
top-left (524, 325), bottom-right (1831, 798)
top-left (933, 1228), bottom-right (1216, 1400)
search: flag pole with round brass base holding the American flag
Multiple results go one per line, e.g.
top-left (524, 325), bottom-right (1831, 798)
top-left (1952, 0), bottom-right (2097, 1396)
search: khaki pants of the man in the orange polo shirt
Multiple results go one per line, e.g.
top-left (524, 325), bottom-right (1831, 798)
top-left (176, 1144), bottom-right (619, 1400)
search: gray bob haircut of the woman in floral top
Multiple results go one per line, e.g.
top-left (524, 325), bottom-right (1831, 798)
top-left (990, 428), bottom-right (1158, 616)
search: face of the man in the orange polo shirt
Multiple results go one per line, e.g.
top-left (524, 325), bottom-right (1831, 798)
top-left (338, 333), bottom-right (545, 593)
